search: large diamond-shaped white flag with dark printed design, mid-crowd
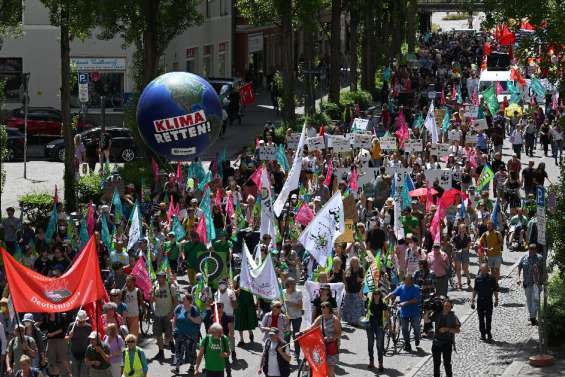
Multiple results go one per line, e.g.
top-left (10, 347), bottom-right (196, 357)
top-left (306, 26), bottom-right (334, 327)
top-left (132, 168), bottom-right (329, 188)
top-left (298, 191), bottom-right (345, 266)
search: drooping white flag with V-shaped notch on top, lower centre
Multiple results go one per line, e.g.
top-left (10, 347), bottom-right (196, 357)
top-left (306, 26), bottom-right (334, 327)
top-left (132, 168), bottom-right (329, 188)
top-left (239, 241), bottom-right (280, 300)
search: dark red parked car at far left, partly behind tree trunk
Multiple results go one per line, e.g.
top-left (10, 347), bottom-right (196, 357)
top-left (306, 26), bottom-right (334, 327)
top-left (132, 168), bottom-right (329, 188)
top-left (6, 107), bottom-right (93, 137)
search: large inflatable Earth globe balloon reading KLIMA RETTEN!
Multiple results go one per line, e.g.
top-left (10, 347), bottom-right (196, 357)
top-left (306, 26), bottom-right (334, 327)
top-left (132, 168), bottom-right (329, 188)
top-left (137, 72), bottom-right (222, 161)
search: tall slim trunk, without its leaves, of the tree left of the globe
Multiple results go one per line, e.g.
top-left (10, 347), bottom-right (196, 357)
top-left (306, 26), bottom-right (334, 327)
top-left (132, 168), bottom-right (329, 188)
top-left (60, 6), bottom-right (76, 213)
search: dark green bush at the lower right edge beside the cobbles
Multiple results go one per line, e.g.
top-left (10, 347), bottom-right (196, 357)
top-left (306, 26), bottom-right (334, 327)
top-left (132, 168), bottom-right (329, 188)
top-left (546, 274), bottom-right (565, 347)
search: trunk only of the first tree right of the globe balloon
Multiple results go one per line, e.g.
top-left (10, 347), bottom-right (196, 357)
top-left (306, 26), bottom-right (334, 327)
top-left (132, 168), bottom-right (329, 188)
top-left (277, 0), bottom-right (296, 125)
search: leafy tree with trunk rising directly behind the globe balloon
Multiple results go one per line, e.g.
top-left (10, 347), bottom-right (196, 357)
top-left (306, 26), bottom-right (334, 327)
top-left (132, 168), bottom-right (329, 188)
top-left (99, 0), bottom-right (202, 91)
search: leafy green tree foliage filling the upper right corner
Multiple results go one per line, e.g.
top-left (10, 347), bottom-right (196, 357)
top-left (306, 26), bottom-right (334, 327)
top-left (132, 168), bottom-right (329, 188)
top-left (483, 0), bottom-right (565, 81)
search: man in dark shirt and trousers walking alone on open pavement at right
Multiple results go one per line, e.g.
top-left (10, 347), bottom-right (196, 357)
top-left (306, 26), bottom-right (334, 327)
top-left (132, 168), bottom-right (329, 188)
top-left (471, 263), bottom-right (498, 342)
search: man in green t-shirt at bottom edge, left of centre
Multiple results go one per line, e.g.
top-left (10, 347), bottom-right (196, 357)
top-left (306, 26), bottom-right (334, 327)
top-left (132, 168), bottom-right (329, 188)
top-left (194, 323), bottom-right (230, 377)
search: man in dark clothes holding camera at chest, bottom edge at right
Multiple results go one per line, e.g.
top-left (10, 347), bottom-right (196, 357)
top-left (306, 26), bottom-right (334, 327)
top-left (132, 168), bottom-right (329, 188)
top-left (432, 299), bottom-right (461, 377)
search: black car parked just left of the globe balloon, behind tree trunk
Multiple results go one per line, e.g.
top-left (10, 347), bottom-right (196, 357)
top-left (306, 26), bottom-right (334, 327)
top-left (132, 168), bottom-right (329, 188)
top-left (45, 127), bottom-right (139, 162)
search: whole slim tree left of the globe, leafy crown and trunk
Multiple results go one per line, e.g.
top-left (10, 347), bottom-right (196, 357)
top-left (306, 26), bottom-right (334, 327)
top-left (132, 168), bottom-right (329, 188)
top-left (41, 0), bottom-right (97, 212)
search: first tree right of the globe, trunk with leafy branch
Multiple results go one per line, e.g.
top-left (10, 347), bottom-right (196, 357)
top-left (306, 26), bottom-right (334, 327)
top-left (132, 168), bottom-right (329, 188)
top-left (236, 0), bottom-right (296, 124)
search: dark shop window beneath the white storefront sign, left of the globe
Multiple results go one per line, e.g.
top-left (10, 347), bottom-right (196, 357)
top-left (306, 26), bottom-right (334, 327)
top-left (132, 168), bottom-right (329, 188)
top-left (71, 71), bottom-right (125, 110)
